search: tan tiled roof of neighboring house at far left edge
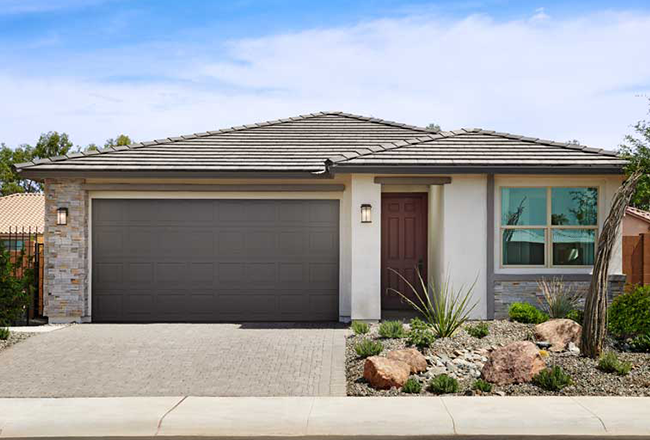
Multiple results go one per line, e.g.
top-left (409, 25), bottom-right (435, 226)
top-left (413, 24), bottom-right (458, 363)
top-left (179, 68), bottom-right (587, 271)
top-left (0, 194), bottom-right (45, 234)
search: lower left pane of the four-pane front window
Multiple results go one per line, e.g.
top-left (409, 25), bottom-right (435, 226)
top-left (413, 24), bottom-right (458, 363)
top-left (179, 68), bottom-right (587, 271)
top-left (502, 229), bottom-right (545, 266)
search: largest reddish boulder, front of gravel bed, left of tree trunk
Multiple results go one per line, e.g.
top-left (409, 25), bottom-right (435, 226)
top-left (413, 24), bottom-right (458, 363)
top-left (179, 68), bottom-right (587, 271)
top-left (481, 341), bottom-right (546, 385)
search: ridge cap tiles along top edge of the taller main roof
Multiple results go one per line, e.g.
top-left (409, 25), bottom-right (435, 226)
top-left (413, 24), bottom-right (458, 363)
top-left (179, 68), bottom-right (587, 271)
top-left (14, 111), bottom-right (437, 169)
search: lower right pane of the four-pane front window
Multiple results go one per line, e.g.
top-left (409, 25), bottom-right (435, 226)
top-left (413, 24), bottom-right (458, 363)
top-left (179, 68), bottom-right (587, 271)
top-left (553, 229), bottom-right (596, 266)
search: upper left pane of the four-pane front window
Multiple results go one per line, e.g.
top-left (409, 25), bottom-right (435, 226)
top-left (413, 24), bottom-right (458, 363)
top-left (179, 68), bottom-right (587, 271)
top-left (501, 188), bottom-right (546, 226)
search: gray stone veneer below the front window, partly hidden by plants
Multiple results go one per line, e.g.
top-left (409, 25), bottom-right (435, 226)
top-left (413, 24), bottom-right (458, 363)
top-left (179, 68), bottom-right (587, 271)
top-left (494, 275), bottom-right (625, 319)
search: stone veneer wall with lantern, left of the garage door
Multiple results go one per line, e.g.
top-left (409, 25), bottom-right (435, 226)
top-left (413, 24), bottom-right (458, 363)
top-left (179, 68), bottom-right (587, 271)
top-left (43, 179), bottom-right (89, 323)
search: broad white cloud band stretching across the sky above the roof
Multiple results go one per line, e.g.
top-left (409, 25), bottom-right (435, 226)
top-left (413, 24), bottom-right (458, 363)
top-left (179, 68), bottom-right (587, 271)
top-left (0, 11), bottom-right (650, 148)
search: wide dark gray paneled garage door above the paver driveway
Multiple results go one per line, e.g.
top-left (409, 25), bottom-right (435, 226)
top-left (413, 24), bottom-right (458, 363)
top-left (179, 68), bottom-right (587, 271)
top-left (92, 199), bottom-right (339, 322)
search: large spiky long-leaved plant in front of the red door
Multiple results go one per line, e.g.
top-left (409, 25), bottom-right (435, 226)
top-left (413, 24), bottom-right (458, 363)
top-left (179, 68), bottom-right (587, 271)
top-left (389, 268), bottom-right (478, 338)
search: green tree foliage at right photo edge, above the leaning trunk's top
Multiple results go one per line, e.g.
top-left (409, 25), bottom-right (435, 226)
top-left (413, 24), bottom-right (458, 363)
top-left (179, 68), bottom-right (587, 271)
top-left (620, 99), bottom-right (650, 211)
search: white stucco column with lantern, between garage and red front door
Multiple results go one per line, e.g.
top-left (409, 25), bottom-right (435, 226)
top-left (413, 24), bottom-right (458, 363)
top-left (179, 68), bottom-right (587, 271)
top-left (350, 175), bottom-right (381, 321)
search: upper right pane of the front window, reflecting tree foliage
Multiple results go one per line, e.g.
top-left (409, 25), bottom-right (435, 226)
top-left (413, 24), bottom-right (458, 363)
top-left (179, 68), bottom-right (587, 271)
top-left (551, 188), bottom-right (598, 226)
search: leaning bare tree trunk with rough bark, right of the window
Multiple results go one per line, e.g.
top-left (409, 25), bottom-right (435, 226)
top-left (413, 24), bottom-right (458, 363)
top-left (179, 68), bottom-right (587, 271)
top-left (580, 171), bottom-right (643, 358)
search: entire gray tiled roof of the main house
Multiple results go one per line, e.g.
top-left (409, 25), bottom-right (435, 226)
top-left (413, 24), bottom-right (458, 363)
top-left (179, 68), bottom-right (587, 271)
top-left (17, 112), bottom-right (625, 178)
